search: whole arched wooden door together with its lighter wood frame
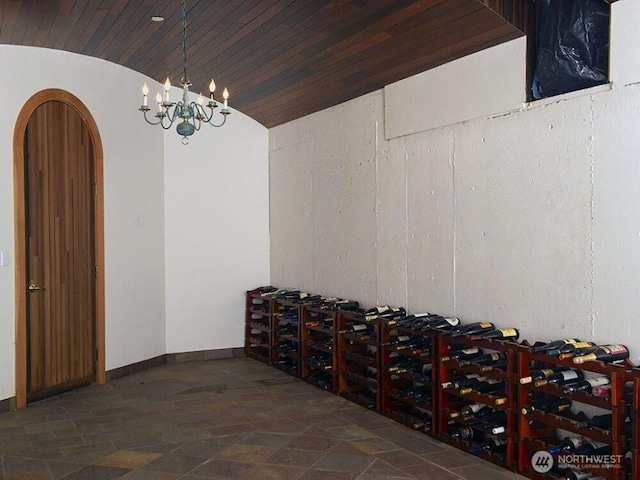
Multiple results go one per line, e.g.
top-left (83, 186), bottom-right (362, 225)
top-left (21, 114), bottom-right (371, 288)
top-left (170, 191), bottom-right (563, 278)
top-left (13, 89), bottom-right (105, 408)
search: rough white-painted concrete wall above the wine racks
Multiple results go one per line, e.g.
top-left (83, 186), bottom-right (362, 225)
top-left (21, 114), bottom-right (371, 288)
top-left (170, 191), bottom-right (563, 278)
top-left (270, 0), bottom-right (640, 361)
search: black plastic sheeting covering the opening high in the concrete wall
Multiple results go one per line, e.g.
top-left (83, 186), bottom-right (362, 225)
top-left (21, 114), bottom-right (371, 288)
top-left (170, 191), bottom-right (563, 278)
top-left (533, 0), bottom-right (610, 98)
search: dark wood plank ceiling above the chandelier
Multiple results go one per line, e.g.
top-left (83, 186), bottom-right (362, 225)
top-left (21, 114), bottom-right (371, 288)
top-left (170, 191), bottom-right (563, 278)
top-left (0, 0), bottom-right (529, 127)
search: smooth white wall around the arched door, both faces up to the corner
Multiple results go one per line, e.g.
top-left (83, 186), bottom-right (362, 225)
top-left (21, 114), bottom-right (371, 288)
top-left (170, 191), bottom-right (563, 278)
top-left (0, 46), bottom-right (269, 400)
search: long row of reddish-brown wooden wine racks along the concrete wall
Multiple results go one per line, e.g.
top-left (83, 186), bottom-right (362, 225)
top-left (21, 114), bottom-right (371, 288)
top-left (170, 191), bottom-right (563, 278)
top-left (244, 292), bottom-right (640, 480)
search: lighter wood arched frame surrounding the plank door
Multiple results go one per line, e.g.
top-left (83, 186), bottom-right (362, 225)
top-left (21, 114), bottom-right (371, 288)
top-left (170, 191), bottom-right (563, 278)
top-left (13, 88), bottom-right (106, 408)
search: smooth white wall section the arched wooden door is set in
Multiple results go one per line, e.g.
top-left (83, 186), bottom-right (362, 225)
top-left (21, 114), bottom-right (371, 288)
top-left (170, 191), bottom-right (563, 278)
top-left (0, 45), bottom-right (165, 399)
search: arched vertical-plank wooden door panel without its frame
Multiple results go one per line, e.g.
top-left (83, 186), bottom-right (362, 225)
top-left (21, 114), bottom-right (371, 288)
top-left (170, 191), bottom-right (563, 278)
top-left (25, 101), bottom-right (95, 399)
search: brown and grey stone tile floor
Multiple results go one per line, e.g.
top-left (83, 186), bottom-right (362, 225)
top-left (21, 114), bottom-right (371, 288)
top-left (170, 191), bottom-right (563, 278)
top-left (0, 358), bottom-right (524, 480)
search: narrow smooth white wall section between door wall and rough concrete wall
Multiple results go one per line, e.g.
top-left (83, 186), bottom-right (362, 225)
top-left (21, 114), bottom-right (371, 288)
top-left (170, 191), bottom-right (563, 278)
top-left (164, 105), bottom-right (269, 353)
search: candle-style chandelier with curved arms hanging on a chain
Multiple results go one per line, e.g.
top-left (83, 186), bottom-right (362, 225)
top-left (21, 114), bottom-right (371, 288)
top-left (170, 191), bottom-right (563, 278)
top-left (138, 0), bottom-right (231, 145)
